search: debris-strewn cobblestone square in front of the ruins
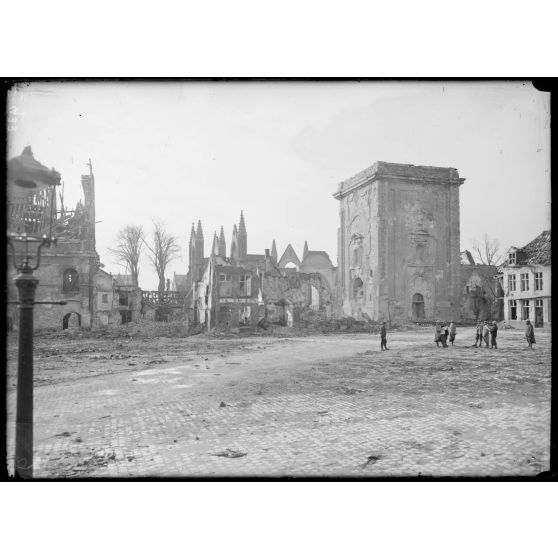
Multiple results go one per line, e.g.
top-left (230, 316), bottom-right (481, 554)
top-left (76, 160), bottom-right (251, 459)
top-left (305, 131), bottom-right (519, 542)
top-left (4, 329), bottom-right (551, 478)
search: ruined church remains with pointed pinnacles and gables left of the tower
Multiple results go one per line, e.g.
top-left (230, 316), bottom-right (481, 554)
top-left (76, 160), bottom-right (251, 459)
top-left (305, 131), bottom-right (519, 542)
top-left (184, 212), bottom-right (336, 330)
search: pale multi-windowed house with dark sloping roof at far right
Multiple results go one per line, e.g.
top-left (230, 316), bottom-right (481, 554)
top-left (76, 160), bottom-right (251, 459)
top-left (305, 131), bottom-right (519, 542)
top-left (499, 230), bottom-right (552, 327)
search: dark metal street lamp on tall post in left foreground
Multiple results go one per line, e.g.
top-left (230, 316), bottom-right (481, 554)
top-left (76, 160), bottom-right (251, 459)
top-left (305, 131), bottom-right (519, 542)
top-left (7, 146), bottom-right (60, 479)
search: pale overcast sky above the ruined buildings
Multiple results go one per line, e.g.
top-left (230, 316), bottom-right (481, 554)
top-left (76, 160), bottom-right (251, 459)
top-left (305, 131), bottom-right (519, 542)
top-left (8, 82), bottom-right (550, 290)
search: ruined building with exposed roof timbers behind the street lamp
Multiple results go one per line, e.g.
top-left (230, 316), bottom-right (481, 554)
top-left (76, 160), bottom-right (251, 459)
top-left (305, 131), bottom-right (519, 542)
top-left (7, 147), bottom-right (137, 329)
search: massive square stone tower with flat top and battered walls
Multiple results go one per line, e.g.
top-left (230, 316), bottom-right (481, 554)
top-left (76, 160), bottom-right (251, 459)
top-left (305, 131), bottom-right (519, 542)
top-left (334, 161), bottom-right (465, 323)
